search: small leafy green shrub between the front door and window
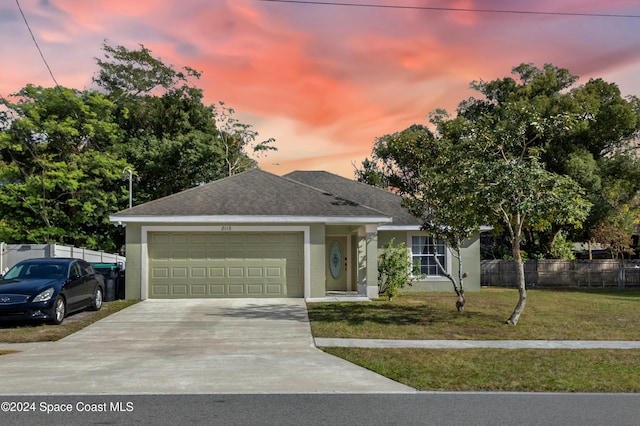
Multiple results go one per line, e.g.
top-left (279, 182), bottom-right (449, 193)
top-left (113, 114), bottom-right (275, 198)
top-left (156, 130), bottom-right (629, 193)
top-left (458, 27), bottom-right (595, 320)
top-left (378, 239), bottom-right (413, 300)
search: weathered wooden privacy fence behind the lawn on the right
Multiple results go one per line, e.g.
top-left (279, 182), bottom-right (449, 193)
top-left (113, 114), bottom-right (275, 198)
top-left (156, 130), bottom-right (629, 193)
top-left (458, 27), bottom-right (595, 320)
top-left (481, 259), bottom-right (640, 288)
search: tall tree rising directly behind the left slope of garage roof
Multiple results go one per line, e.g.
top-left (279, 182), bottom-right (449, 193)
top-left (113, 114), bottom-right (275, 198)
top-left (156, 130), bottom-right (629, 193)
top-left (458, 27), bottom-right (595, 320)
top-left (94, 43), bottom-right (276, 202)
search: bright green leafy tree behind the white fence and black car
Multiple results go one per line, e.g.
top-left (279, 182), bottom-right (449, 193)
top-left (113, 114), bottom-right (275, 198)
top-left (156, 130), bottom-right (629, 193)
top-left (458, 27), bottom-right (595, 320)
top-left (0, 85), bottom-right (130, 250)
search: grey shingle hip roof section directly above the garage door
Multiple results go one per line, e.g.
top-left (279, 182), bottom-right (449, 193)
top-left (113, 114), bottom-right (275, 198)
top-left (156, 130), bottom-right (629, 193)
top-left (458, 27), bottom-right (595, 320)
top-left (110, 169), bottom-right (390, 222)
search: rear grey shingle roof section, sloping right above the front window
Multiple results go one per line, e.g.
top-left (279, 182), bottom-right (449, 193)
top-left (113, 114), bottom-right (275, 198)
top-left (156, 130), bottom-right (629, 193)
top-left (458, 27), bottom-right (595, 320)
top-left (284, 171), bottom-right (421, 226)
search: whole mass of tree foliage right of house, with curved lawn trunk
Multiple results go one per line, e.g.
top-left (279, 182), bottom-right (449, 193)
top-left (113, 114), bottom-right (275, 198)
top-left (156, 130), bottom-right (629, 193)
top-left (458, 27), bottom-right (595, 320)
top-left (357, 64), bottom-right (640, 324)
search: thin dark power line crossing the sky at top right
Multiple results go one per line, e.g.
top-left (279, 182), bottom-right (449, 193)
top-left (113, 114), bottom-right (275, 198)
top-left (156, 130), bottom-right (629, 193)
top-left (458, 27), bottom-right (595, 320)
top-left (258, 0), bottom-right (640, 19)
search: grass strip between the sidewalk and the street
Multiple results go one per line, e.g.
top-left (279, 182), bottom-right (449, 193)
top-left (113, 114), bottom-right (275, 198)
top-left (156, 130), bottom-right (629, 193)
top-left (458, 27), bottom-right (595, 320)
top-left (322, 348), bottom-right (640, 393)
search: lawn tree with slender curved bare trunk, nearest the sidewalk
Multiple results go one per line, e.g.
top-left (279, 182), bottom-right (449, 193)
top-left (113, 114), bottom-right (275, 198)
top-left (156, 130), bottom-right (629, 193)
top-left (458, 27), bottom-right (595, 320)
top-left (448, 64), bottom-right (591, 325)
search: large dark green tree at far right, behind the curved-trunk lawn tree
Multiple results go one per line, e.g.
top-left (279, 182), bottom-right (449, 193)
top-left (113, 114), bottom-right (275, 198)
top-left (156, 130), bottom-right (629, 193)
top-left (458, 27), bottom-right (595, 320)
top-left (502, 72), bottom-right (640, 256)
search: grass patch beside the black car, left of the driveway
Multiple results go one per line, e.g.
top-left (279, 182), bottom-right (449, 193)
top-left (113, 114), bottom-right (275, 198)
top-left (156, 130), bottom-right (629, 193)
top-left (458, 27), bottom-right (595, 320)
top-left (0, 300), bottom-right (137, 342)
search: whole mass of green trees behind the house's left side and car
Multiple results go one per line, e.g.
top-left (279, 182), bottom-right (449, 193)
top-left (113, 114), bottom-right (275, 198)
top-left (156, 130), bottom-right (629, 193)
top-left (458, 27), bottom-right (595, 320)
top-left (0, 43), bottom-right (276, 250)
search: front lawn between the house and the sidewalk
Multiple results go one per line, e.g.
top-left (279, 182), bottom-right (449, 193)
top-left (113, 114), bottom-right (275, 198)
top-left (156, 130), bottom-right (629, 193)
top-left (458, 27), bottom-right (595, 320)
top-left (308, 288), bottom-right (640, 340)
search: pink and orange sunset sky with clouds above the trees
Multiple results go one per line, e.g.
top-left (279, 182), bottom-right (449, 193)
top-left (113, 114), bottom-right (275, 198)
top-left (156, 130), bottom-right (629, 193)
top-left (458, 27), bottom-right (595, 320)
top-left (0, 0), bottom-right (640, 178)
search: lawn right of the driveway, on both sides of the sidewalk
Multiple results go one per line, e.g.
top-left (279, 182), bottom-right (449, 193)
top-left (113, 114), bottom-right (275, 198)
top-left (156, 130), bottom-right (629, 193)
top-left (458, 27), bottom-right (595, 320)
top-left (309, 288), bottom-right (640, 392)
